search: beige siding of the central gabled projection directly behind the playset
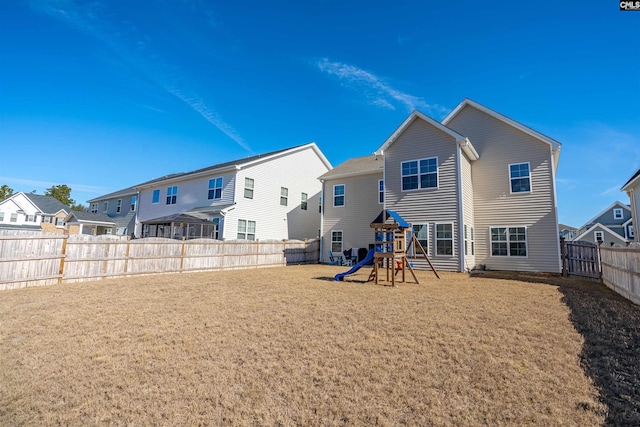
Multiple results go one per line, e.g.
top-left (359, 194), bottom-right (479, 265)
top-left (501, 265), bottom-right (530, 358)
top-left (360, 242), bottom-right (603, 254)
top-left (385, 118), bottom-right (460, 271)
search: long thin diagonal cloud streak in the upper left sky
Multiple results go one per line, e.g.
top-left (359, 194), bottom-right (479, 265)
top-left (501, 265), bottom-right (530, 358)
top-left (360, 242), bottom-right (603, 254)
top-left (30, 0), bottom-right (253, 153)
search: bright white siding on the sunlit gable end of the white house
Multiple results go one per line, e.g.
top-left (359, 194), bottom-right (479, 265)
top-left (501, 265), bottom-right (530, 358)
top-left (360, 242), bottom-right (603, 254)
top-left (224, 146), bottom-right (329, 240)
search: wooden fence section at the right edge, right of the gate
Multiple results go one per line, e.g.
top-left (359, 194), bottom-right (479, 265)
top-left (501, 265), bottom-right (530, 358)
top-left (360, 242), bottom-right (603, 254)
top-left (600, 243), bottom-right (640, 304)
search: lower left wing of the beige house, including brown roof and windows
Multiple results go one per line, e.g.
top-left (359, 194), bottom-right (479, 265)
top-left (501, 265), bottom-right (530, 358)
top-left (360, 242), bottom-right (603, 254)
top-left (320, 154), bottom-right (384, 259)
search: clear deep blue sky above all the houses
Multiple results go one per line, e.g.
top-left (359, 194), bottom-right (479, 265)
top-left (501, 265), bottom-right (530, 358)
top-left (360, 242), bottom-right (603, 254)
top-left (0, 0), bottom-right (640, 226)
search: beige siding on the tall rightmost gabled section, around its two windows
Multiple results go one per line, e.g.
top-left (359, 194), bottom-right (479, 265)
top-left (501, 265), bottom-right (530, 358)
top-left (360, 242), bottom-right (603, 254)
top-left (447, 106), bottom-right (560, 272)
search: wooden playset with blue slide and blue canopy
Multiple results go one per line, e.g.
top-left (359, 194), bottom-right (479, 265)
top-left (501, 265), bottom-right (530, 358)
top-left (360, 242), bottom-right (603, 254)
top-left (334, 209), bottom-right (440, 286)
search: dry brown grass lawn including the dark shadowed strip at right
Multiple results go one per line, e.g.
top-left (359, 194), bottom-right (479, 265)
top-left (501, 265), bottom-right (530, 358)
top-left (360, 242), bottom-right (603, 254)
top-left (0, 266), bottom-right (640, 426)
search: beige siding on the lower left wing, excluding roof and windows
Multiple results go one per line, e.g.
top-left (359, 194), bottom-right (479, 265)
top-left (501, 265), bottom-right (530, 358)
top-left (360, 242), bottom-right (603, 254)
top-left (321, 173), bottom-right (383, 262)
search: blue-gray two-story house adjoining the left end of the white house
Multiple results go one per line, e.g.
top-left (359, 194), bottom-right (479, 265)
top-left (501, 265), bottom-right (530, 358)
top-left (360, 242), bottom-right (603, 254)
top-left (87, 187), bottom-right (138, 236)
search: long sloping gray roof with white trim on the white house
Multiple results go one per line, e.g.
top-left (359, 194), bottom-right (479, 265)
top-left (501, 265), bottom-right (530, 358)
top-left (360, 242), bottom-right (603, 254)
top-left (133, 142), bottom-right (331, 189)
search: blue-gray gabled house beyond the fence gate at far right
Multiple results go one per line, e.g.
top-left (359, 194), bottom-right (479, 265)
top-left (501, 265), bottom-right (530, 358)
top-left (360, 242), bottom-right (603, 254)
top-left (574, 202), bottom-right (633, 245)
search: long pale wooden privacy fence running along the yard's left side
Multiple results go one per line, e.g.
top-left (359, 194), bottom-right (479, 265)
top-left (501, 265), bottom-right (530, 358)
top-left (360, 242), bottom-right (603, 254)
top-left (0, 230), bottom-right (319, 290)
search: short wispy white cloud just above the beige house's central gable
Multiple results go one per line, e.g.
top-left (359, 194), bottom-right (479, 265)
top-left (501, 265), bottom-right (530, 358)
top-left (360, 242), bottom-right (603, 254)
top-left (315, 58), bottom-right (450, 115)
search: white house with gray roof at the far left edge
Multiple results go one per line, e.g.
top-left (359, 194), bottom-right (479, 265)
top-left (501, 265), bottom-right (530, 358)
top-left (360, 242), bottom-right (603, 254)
top-left (0, 192), bottom-right (71, 234)
